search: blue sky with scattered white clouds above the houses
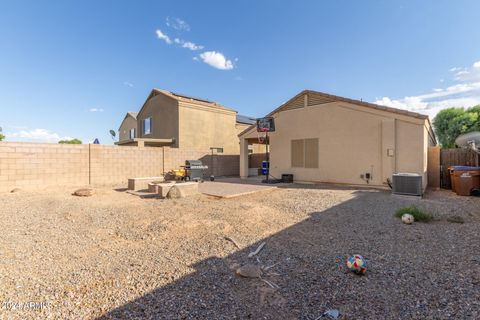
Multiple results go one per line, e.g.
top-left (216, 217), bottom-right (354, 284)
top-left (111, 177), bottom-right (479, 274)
top-left (0, 0), bottom-right (480, 143)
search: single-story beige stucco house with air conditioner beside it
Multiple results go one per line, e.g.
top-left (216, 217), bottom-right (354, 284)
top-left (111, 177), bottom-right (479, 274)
top-left (239, 90), bottom-right (436, 188)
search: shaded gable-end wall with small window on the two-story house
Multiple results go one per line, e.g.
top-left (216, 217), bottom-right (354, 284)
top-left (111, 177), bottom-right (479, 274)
top-left (137, 94), bottom-right (179, 147)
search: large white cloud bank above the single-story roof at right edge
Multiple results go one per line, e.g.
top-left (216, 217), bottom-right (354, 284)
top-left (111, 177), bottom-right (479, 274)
top-left (374, 61), bottom-right (480, 118)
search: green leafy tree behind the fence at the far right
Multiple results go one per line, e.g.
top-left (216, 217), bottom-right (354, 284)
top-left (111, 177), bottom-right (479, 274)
top-left (433, 106), bottom-right (480, 148)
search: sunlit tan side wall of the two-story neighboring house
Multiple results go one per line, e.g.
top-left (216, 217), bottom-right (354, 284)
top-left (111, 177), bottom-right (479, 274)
top-left (179, 102), bottom-right (240, 154)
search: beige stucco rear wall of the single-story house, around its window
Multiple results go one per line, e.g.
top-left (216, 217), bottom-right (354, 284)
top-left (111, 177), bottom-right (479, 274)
top-left (241, 102), bottom-right (427, 186)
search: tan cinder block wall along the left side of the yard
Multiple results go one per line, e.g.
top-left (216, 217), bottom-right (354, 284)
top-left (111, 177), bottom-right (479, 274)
top-left (0, 142), bottom-right (240, 192)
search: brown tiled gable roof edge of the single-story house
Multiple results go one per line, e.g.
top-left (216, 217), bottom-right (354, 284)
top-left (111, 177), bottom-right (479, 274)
top-left (239, 90), bottom-right (436, 141)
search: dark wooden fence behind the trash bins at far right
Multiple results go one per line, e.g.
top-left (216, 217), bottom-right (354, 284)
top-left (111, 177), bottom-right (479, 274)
top-left (440, 148), bottom-right (479, 189)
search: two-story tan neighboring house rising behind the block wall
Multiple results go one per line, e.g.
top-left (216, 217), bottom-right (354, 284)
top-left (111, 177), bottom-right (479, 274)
top-left (117, 89), bottom-right (255, 154)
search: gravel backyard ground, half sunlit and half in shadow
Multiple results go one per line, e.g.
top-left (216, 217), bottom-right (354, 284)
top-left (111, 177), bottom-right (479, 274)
top-left (0, 185), bottom-right (480, 320)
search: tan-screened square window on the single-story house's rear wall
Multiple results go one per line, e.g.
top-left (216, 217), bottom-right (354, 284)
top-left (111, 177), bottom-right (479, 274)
top-left (291, 138), bottom-right (318, 168)
